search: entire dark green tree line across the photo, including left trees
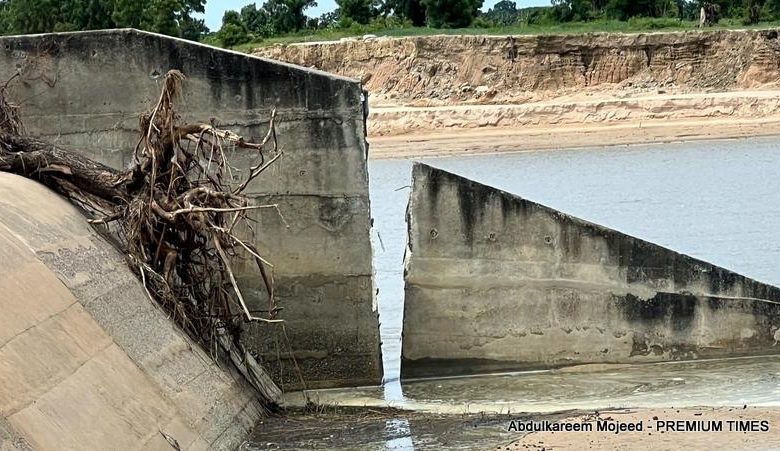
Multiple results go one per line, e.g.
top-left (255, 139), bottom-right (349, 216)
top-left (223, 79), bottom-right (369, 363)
top-left (0, 0), bottom-right (780, 47)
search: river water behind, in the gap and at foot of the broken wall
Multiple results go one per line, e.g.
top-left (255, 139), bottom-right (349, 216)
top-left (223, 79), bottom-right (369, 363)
top-left (251, 138), bottom-right (780, 449)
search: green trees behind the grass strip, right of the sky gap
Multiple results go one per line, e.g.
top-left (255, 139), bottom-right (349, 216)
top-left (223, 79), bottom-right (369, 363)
top-left (214, 0), bottom-right (780, 46)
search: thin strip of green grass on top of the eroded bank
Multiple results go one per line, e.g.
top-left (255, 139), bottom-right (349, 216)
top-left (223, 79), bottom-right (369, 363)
top-left (225, 18), bottom-right (780, 52)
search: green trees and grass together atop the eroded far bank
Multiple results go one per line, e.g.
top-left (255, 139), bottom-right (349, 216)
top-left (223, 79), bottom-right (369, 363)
top-left (206, 0), bottom-right (780, 50)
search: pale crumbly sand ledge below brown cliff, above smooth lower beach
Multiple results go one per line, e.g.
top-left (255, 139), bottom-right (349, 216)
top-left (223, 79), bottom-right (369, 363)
top-left (369, 91), bottom-right (780, 137)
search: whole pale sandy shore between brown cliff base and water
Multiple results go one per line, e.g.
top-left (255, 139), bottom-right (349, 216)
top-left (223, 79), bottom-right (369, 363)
top-left (369, 90), bottom-right (780, 159)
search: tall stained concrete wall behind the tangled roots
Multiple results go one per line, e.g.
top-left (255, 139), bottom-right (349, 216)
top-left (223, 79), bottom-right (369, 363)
top-left (0, 30), bottom-right (381, 389)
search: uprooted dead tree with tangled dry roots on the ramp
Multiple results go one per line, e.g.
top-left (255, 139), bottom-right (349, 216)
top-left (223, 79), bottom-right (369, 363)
top-left (0, 71), bottom-right (282, 407)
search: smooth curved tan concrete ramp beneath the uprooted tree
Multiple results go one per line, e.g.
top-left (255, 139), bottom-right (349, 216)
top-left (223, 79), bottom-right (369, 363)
top-left (0, 173), bottom-right (260, 451)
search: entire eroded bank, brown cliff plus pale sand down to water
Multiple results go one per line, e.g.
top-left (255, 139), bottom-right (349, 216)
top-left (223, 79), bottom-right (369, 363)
top-left (255, 30), bottom-right (780, 158)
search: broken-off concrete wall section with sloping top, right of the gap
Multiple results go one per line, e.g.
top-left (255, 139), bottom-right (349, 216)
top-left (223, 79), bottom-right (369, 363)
top-left (401, 164), bottom-right (780, 378)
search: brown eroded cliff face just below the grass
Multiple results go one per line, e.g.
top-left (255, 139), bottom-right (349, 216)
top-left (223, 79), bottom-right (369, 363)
top-left (255, 30), bottom-right (780, 106)
